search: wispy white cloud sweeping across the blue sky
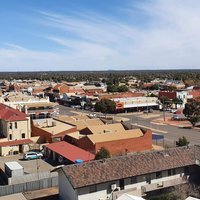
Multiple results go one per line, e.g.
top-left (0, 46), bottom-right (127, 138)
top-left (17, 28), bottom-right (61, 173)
top-left (0, 0), bottom-right (200, 70)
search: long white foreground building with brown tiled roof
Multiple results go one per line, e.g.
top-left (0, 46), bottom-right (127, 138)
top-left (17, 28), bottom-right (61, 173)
top-left (55, 146), bottom-right (200, 200)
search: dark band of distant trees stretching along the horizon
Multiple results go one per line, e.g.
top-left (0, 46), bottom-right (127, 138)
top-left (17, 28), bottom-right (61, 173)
top-left (0, 70), bottom-right (200, 85)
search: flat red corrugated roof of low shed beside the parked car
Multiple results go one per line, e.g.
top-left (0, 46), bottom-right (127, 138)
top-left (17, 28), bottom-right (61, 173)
top-left (46, 141), bottom-right (95, 162)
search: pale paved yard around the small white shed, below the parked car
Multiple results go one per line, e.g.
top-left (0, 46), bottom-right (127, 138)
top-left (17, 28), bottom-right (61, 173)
top-left (0, 154), bottom-right (54, 173)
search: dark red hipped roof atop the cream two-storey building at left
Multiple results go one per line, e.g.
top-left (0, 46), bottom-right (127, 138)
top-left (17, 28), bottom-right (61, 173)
top-left (0, 103), bottom-right (27, 121)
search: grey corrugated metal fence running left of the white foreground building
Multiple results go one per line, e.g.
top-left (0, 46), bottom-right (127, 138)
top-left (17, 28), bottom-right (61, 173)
top-left (0, 176), bottom-right (58, 196)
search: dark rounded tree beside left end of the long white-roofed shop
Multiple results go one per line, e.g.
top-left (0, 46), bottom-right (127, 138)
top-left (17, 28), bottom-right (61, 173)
top-left (94, 99), bottom-right (116, 113)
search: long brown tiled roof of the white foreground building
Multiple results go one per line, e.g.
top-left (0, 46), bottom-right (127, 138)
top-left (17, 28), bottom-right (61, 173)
top-left (59, 146), bottom-right (200, 188)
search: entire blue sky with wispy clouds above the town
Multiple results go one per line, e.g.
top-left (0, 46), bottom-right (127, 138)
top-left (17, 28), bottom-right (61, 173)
top-left (0, 0), bottom-right (200, 71)
